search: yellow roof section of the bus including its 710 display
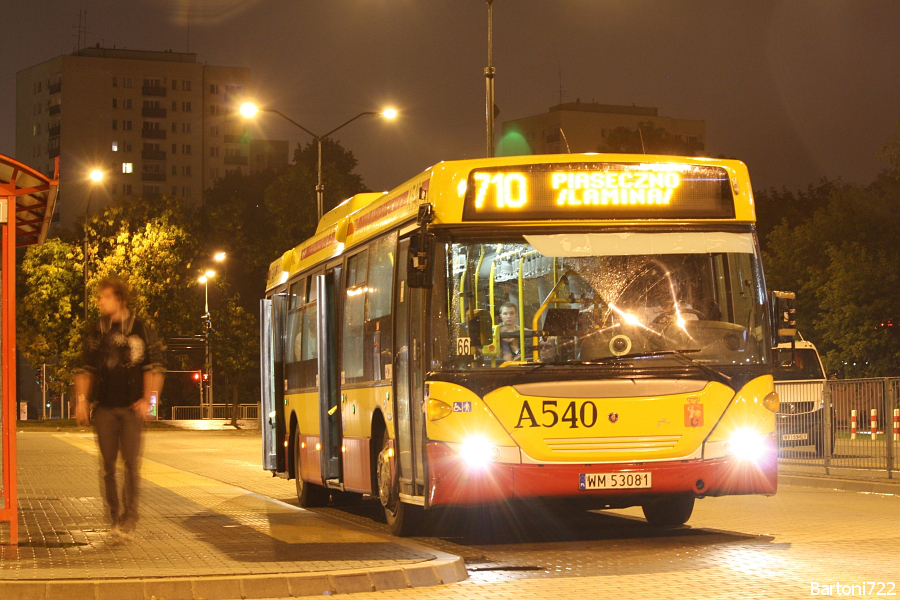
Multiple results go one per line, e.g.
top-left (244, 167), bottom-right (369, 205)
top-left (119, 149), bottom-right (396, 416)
top-left (266, 154), bottom-right (756, 289)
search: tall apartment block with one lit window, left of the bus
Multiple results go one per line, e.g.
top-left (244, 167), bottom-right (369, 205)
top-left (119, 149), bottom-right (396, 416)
top-left (16, 47), bottom-right (288, 227)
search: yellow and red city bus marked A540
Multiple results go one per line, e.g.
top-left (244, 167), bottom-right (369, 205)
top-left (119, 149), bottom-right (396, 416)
top-left (261, 154), bottom-right (793, 535)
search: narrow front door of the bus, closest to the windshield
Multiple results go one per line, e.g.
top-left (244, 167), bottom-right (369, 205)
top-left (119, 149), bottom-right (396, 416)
top-left (394, 240), bottom-right (428, 497)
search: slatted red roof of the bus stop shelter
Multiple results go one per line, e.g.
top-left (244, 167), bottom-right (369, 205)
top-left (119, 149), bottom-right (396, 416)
top-left (0, 154), bottom-right (59, 248)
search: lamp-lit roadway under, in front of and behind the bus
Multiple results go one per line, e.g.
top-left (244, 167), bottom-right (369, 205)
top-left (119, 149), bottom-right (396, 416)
top-left (145, 430), bottom-right (900, 599)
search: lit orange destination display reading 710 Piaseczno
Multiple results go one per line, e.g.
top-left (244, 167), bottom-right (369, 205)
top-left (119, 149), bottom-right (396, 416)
top-left (463, 163), bottom-right (734, 221)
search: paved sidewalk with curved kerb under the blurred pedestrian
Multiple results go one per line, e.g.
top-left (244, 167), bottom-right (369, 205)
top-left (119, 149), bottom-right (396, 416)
top-left (0, 432), bottom-right (467, 600)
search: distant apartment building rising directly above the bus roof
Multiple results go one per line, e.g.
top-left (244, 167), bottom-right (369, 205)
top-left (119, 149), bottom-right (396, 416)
top-left (503, 101), bottom-right (706, 154)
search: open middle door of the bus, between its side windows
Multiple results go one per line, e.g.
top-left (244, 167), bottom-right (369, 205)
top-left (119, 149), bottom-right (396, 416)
top-left (316, 267), bottom-right (341, 487)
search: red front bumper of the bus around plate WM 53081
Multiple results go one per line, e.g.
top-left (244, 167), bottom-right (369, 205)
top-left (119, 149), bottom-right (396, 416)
top-left (426, 442), bottom-right (778, 506)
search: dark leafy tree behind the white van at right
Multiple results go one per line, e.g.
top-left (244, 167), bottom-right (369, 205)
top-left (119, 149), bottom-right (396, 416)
top-left (765, 175), bottom-right (900, 376)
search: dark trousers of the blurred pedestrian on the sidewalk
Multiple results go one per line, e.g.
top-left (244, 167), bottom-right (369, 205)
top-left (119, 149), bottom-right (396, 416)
top-left (94, 406), bottom-right (143, 528)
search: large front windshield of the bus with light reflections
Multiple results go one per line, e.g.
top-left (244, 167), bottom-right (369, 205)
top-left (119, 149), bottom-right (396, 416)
top-left (435, 231), bottom-right (771, 369)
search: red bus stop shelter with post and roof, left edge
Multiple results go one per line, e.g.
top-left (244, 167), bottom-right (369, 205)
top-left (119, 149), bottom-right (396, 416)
top-left (0, 154), bottom-right (59, 544)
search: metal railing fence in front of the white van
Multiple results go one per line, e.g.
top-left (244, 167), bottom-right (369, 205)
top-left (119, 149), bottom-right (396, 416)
top-left (775, 377), bottom-right (900, 478)
